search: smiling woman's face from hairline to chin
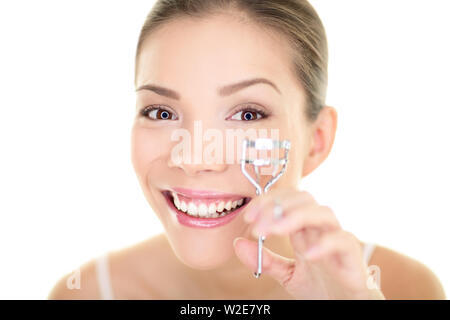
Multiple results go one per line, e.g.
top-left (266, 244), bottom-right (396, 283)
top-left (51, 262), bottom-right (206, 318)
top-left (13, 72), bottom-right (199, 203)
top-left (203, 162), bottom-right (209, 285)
top-left (132, 16), bottom-right (310, 270)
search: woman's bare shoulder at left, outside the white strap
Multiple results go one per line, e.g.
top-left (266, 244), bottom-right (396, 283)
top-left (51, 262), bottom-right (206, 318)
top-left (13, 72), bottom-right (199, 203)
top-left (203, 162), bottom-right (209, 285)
top-left (47, 259), bottom-right (100, 300)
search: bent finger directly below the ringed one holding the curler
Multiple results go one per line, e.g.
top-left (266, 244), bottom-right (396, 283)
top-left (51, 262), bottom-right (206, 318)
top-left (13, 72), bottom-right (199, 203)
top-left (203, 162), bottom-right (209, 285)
top-left (259, 205), bottom-right (341, 235)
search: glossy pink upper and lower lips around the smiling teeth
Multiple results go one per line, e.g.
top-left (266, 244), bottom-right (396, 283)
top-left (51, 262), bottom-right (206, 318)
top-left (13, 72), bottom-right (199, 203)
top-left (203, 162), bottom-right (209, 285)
top-left (162, 188), bottom-right (250, 228)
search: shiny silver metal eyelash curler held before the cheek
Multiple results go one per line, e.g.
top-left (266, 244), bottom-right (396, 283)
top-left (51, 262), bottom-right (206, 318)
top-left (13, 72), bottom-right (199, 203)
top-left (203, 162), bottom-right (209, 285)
top-left (241, 138), bottom-right (291, 278)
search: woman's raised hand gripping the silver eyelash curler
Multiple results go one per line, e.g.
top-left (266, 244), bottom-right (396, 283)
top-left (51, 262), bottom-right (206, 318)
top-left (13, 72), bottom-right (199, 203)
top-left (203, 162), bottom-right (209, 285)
top-left (234, 189), bottom-right (385, 299)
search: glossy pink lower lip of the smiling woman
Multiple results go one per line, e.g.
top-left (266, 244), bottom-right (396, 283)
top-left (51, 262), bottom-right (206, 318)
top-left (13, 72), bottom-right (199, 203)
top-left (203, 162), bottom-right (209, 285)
top-left (163, 194), bottom-right (247, 228)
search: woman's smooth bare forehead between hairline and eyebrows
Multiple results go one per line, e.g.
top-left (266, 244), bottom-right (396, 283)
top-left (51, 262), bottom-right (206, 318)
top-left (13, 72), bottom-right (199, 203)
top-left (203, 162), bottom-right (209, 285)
top-left (136, 15), bottom-right (298, 99)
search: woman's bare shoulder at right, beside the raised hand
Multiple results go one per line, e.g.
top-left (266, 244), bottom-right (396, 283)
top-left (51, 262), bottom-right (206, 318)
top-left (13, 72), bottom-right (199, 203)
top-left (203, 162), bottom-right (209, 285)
top-left (362, 245), bottom-right (446, 300)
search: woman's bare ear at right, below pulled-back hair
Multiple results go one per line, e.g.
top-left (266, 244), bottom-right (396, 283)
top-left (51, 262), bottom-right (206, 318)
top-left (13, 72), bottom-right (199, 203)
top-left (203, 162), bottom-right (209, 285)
top-left (302, 106), bottom-right (337, 177)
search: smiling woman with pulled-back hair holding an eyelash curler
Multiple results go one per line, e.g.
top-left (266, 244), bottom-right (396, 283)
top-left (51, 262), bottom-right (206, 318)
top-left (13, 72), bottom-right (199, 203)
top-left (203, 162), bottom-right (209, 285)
top-left (49, 0), bottom-right (445, 299)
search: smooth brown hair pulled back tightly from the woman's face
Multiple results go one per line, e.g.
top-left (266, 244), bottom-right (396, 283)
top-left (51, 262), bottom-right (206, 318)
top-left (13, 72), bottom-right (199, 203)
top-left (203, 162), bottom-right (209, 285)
top-left (135, 0), bottom-right (328, 122)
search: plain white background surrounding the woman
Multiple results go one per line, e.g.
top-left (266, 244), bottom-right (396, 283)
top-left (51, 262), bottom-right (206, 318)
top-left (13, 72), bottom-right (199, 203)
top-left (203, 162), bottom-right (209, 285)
top-left (0, 0), bottom-right (450, 299)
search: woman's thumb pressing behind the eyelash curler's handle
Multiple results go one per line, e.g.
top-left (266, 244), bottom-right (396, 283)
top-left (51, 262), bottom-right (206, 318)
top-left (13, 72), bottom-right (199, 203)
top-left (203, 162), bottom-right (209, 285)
top-left (233, 237), bottom-right (295, 286)
